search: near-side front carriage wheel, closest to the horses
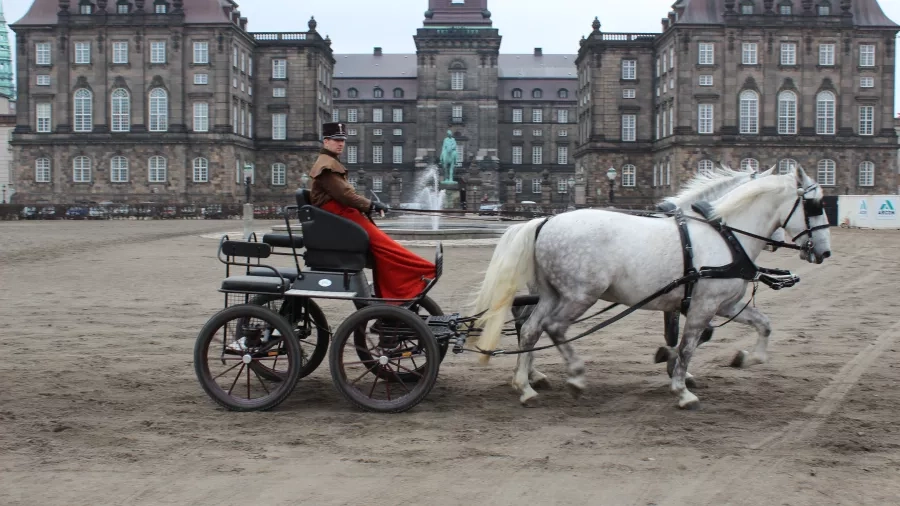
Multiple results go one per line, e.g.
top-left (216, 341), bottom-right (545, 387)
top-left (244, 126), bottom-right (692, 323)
top-left (328, 305), bottom-right (440, 413)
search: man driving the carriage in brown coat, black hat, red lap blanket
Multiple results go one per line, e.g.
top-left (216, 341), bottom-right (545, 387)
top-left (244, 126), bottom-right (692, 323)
top-left (309, 123), bottom-right (435, 299)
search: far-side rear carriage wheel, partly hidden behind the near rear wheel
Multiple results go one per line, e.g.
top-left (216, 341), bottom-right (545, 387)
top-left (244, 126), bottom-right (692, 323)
top-left (250, 295), bottom-right (331, 381)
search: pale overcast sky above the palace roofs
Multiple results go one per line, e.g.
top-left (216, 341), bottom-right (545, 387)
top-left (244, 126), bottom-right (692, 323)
top-left (0, 0), bottom-right (900, 113)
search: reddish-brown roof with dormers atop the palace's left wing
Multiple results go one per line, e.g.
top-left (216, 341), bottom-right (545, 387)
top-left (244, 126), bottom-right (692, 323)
top-left (12, 0), bottom-right (237, 26)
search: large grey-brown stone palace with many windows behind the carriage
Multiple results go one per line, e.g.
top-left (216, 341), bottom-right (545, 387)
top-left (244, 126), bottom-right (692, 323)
top-left (13, 0), bottom-right (900, 206)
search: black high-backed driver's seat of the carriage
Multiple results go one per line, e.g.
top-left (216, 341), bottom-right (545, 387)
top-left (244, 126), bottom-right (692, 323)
top-left (295, 188), bottom-right (370, 271)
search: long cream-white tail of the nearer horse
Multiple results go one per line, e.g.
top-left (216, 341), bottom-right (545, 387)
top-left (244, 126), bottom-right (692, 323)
top-left (475, 218), bottom-right (546, 364)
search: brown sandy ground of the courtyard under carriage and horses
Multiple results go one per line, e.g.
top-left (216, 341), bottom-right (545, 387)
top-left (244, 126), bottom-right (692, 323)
top-left (0, 221), bottom-right (900, 506)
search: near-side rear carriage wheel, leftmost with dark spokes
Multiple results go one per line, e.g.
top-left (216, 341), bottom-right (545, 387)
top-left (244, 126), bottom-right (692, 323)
top-left (194, 304), bottom-right (302, 411)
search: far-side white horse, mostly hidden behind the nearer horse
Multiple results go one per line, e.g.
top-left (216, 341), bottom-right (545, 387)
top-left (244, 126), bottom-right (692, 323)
top-left (512, 165), bottom-right (784, 388)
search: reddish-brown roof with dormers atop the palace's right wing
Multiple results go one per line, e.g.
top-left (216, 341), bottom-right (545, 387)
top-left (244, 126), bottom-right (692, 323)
top-left (672, 0), bottom-right (900, 28)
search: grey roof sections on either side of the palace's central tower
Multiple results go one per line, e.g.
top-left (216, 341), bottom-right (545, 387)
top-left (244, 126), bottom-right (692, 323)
top-left (334, 53), bottom-right (578, 79)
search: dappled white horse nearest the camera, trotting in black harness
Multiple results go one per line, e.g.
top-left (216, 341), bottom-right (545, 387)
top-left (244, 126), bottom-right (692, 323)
top-left (475, 166), bottom-right (831, 409)
